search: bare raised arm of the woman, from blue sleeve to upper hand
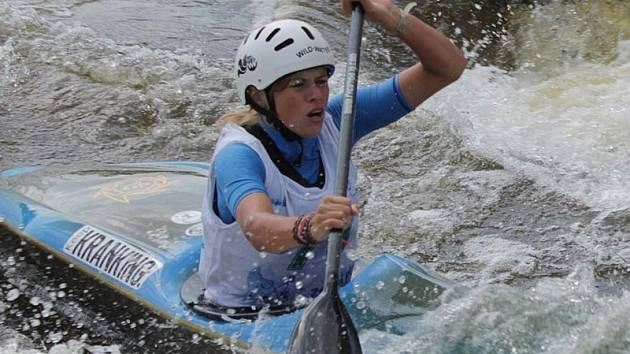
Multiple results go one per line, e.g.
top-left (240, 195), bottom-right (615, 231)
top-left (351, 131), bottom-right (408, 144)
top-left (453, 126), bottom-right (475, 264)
top-left (341, 0), bottom-right (466, 107)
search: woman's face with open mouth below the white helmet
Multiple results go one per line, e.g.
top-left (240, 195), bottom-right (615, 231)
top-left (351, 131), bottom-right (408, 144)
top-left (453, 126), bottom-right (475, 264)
top-left (272, 67), bottom-right (328, 138)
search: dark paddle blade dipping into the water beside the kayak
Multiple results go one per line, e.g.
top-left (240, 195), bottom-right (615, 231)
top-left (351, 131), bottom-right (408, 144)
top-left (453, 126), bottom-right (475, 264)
top-left (287, 289), bottom-right (362, 354)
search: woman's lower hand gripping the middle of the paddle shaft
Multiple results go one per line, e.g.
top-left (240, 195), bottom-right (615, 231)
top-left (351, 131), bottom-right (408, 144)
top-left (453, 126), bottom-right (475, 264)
top-left (310, 195), bottom-right (359, 242)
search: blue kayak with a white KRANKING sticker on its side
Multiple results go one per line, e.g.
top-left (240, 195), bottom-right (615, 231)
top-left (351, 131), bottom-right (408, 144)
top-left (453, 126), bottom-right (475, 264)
top-left (0, 162), bottom-right (454, 352)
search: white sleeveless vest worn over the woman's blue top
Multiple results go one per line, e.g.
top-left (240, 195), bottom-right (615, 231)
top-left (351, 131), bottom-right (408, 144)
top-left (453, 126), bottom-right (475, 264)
top-left (199, 113), bottom-right (358, 307)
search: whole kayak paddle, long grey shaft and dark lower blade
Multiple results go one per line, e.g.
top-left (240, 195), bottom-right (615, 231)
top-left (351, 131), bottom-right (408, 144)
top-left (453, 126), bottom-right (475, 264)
top-left (288, 3), bottom-right (363, 354)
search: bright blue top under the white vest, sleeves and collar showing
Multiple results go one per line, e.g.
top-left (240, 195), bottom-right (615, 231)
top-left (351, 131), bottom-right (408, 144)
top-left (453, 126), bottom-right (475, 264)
top-left (212, 76), bottom-right (414, 224)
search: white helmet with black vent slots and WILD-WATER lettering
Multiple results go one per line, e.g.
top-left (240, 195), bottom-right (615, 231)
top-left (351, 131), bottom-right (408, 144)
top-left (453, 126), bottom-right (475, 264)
top-left (234, 20), bottom-right (335, 104)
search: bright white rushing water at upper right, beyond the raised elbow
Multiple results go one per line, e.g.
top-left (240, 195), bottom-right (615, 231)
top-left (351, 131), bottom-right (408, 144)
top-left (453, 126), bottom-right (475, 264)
top-left (429, 2), bottom-right (630, 209)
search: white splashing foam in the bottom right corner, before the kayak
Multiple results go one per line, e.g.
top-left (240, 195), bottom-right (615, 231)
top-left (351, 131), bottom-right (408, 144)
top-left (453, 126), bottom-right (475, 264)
top-left (361, 265), bottom-right (630, 354)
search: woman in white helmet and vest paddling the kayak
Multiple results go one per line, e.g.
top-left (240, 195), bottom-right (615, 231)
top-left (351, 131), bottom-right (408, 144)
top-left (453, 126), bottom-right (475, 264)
top-left (199, 0), bottom-right (466, 313)
